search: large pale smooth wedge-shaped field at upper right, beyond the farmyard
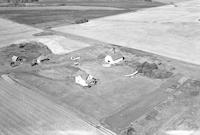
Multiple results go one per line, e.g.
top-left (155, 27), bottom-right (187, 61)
top-left (53, 0), bottom-right (200, 64)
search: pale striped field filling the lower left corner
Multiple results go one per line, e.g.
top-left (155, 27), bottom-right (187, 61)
top-left (0, 78), bottom-right (108, 135)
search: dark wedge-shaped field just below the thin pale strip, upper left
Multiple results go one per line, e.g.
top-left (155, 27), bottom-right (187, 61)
top-left (0, 10), bottom-right (127, 28)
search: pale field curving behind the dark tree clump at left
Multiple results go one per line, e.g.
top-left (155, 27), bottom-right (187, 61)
top-left (0, 19), bottom-right (89, 54)
